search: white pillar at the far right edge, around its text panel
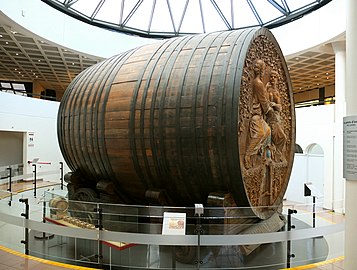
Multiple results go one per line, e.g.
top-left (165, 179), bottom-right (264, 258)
top-left (344, 0), bottom-right (357, 270)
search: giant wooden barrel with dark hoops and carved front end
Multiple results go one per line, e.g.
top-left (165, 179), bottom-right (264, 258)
top-left (58, 28), bottom-right (295, 218)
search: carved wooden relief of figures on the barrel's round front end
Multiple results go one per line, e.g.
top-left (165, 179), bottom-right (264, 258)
top-left (238, 36), bottom-right (294, 211)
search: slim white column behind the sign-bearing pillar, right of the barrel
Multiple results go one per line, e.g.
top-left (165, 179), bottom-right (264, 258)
top-left (331, 41), bottom-right (346, 213)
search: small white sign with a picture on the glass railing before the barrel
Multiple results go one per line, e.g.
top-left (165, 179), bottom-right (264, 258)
top-left (162, 212), bottom-right (186, 235)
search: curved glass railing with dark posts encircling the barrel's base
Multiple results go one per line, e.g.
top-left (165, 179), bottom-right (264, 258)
top-left (0, 186), bottom-right (344, 269)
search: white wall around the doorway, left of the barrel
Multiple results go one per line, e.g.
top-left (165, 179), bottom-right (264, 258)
top-left (0, 92), bottom-right (69, 181)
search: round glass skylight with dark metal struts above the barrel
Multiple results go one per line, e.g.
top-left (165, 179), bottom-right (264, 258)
top-left (42, 0), bottom-right (332, 38)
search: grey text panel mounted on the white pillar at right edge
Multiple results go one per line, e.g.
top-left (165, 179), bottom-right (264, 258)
top-left (343, 115), bottom-right (357, 180)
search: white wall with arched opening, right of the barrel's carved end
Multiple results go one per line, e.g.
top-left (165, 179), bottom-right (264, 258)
top-left (285, 105), bottom-right (343, 210)
